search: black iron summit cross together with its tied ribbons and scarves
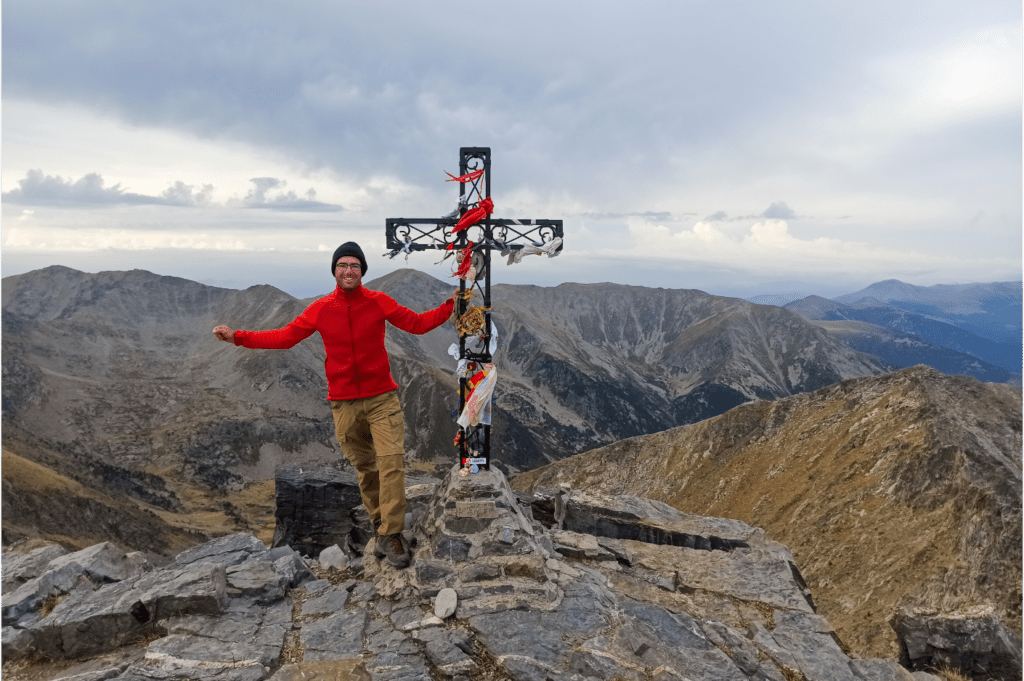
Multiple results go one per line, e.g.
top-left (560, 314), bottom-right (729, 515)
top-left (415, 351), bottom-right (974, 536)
top-left (384, 146), bottom-right (563, 470)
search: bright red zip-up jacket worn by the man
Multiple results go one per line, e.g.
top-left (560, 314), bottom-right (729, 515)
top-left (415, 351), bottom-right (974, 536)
top-left (234, 286), bottom-right (455, 399)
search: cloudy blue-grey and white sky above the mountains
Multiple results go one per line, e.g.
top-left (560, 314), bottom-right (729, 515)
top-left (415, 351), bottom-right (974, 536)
top-left (0, 0), bottom-right (1022, 297)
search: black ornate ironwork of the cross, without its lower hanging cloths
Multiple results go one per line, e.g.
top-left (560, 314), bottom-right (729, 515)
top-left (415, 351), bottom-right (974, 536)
top-left (385, 146), bottom-right (563, 470)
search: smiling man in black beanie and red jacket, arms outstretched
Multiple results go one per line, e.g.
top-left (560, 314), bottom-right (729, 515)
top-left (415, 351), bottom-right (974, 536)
top-left (213, 242), bottom-right (455, 568)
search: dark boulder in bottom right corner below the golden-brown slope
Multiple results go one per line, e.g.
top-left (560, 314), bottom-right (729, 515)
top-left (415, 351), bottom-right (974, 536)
top-left (890, 607), bottom-right (1024, 681)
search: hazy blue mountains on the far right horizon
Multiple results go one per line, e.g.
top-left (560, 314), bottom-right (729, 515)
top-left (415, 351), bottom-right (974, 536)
top-left (751, 280), bottom-right (1024, 385)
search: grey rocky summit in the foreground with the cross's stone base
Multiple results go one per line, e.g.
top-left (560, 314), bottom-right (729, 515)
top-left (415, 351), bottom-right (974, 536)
top-left (2, 467), bottom-right (950, 681)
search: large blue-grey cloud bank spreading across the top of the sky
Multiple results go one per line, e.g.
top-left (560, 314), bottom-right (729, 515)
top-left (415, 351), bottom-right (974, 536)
top-left (0, 0), bottom-right (921, 198)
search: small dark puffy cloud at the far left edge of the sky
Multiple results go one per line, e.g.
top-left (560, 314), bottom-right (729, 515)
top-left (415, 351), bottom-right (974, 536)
top-left (6, 169), bottom-right (213, 206)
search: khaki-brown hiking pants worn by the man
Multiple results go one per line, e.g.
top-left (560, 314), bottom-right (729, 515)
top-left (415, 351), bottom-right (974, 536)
top-left (331, 390), bottom-right (406, 535)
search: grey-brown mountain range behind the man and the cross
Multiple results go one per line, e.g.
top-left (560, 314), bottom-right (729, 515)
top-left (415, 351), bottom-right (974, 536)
top-left (0, 266), bottom-right (1004, 553)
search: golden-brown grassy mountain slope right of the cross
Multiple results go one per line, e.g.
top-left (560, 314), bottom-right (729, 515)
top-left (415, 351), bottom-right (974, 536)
top-left (513, 367), bottom-right (1024, 667)
